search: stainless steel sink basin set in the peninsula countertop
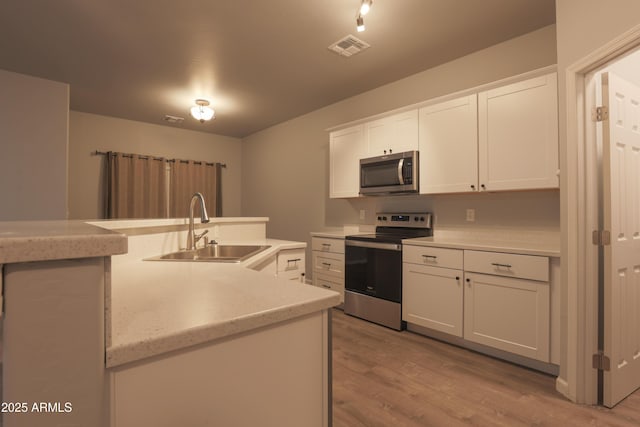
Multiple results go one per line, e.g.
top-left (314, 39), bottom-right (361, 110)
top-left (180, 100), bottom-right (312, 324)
top-left (145, 245), bottom-right (271, 262)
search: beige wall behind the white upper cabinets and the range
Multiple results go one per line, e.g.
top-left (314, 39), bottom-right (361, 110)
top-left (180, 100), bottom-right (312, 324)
top-left (242, 26), bottom-right (559, 246)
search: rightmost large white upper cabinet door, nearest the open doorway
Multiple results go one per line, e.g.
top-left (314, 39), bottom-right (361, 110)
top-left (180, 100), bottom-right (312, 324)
top-left (478, 73), bottom-right (559, 191)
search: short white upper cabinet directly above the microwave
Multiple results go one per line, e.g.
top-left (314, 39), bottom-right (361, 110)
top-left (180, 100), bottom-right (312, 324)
top-left (364, 110), bottom-right (418, 157)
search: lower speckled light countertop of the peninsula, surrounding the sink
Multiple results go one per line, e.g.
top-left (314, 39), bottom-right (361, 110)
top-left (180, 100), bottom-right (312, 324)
top-left (107, 246), bottom-right (340, 367)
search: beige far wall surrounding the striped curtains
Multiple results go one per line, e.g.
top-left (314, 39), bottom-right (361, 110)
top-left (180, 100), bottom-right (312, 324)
top-left (69, 111), bottom-right (242, 219)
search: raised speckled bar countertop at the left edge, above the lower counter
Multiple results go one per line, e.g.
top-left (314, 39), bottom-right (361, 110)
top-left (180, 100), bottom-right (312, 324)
top-left (0, 221), bottom-right (127, 264)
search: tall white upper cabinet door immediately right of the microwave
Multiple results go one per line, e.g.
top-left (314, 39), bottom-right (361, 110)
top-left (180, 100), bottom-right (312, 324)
top-left (419, 94), bottom-right (478, 194)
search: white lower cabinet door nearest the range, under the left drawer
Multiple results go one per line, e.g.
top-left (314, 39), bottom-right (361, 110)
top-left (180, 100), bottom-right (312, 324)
top-left (402, 263), bottom-right (464, 337)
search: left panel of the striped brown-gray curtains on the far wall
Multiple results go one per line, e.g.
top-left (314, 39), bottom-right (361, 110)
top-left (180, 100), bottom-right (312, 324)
top-left (105, 152), bottom-right (167, 218)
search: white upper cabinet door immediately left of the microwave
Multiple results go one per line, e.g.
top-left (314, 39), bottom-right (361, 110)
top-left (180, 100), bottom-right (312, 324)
top-left (329, 125), bottom-right (366, 198)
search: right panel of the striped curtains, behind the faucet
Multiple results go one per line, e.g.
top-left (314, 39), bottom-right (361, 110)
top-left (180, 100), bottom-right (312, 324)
top-left (169, 160), bottom-right (222, 218)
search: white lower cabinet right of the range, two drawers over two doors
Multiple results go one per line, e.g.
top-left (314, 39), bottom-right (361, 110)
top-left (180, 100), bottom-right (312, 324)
top-left (402, 244), bottom-right (555, 363)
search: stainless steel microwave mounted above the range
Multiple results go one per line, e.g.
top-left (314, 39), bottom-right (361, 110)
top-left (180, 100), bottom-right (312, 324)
top-left (360, 151), bottom-right (419, 195)
